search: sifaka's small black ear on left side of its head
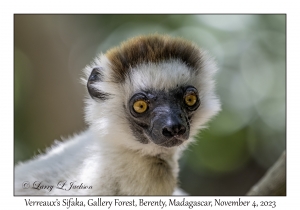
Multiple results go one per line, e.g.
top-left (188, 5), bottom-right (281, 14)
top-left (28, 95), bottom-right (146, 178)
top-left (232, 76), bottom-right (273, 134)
top-left (87, 67), bottom-right (109, 100)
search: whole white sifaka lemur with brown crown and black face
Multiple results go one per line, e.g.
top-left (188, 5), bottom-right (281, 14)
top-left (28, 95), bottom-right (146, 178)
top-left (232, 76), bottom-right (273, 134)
top-left (15, 34), bottom-right (220, 195)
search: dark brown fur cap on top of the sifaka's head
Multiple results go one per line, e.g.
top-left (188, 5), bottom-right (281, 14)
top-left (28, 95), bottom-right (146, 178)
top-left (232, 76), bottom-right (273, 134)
top-left (106, 34), bottom-right (202, 82)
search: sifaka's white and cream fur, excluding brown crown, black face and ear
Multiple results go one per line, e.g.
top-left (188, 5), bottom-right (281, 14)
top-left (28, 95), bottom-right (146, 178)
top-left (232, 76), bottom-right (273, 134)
top-left (15, 49), bottom-right (220, 195)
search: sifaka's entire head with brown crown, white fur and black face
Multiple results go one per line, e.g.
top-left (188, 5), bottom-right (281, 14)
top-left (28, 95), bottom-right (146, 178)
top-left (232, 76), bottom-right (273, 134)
top-left (85, 35), bottom-right (220, 153)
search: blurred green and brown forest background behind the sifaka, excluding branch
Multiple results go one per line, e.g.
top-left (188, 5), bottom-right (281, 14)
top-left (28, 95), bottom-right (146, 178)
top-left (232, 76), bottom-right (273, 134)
top-left (14, 15), bottom-right (286, 195)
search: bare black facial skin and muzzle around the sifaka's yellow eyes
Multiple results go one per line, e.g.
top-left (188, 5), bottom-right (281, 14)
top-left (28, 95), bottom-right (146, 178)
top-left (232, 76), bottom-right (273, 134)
top-left (128, 86), bottom-right (200, 147)
